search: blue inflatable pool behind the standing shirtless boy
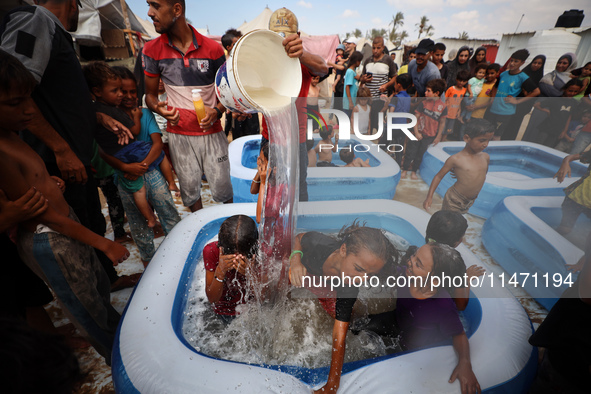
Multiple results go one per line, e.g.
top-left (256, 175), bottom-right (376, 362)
top-left (420, 141), bottom-right (587, 219)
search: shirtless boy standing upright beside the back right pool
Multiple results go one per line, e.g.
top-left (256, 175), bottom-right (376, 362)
top-left (423, 119), bottom-right (494, 214)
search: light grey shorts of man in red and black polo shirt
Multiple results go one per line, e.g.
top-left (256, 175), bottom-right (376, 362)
top-left (168, 132), bottom-right (233, 207)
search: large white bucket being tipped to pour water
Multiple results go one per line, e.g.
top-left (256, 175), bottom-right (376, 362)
top-left (215, 30), bottom-right (302, 113)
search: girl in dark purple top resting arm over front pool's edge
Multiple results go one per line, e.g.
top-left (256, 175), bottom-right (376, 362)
top-left (356, 242), bottom-right (481, 393)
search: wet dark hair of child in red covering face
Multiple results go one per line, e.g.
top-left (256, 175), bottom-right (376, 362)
top-left (218, 215), bottom-right (259, 258)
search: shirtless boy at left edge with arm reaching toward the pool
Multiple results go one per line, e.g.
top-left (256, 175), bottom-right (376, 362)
top-left (0, 51), bottom-right (129, 364)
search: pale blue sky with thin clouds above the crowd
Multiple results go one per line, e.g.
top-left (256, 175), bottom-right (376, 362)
top-left (127, 0), bottom-right (591, 40)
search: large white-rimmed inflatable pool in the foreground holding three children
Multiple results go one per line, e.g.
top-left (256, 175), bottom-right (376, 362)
top-left (112, 200), bottom-right (537, 394)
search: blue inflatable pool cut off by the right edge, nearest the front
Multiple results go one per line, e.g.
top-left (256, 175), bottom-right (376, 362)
top-left (482, 196), bottom-right (591, 310)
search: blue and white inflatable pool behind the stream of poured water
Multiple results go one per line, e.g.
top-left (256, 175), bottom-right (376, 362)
top-left (229, 135), bottom-right (400, 202)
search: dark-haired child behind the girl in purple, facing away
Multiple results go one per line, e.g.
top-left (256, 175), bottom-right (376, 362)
top-left (425, 210), bottom-right (485, 311)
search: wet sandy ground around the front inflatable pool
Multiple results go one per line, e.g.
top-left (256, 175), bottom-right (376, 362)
top-left (56, 164), bottom-right (548, 394)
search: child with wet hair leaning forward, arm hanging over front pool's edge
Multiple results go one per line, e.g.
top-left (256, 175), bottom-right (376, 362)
top-left (289, 222), bottom-right (398, 393)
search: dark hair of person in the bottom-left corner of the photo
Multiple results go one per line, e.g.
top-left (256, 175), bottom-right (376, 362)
top-left (0, 317), bottom-right (82, 394)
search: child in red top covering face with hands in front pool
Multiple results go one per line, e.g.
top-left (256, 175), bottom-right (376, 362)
top-left (203, 215), bottom-right (258, 323)
